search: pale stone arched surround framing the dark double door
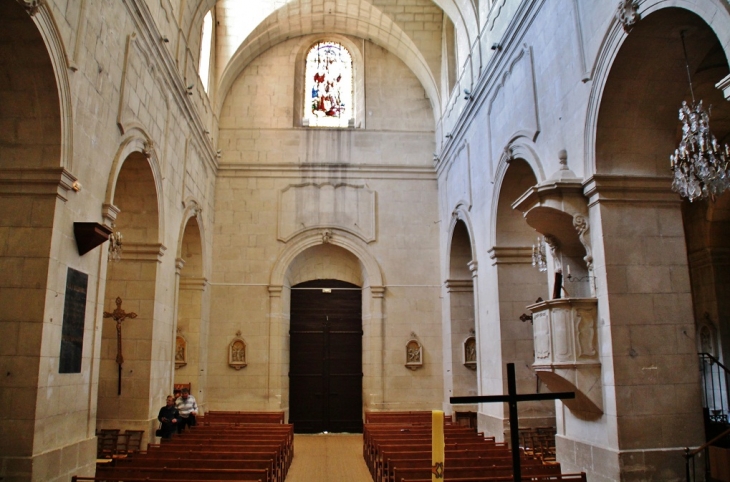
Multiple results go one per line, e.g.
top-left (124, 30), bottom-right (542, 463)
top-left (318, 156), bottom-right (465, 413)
top-left (267, 228), bottom-right (385, 410)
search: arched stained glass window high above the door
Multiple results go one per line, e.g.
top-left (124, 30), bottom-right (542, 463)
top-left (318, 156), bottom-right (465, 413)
top-left (304, 42), bottom-right (354, 127)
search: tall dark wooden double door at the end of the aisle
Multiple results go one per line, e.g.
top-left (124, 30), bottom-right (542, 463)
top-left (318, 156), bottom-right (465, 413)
top-left (289, 280), bottom-right (362, 433)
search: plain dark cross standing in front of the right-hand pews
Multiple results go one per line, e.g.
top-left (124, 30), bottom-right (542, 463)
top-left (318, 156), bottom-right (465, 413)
top-left (449, 363), bottom-right (575, 482)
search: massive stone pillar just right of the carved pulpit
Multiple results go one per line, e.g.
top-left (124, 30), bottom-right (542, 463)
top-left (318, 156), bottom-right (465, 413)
top-left (556, 176), bottom-right (704, 480)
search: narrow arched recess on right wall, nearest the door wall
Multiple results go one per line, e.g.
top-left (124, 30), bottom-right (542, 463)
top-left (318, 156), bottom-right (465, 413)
top-left (444, 209), bottom-right (481, 412)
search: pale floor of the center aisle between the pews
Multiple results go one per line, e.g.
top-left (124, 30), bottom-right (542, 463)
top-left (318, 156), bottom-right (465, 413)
top-left (286, 433), bottom-right (373, 482)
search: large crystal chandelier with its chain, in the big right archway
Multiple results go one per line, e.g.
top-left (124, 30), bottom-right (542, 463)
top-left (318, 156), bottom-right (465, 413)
top-left (669, 32), bottom-right (730, 202)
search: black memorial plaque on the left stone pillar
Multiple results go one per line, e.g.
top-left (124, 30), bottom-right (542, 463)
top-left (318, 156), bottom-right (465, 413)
top-left (58, 268), bottom-right (89, 373)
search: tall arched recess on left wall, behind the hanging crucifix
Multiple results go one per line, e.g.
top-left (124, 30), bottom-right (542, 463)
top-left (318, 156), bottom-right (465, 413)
top-left (97, 149), bottom-right (162, 440)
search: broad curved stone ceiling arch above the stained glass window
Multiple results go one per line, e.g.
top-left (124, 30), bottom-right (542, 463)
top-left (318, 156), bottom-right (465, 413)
top-left (215, 0), bottom-right (441, 118)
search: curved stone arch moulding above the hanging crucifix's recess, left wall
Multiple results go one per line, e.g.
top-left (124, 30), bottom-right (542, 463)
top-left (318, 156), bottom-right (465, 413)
top-left (102, 129), bottom-right (165, 242)
